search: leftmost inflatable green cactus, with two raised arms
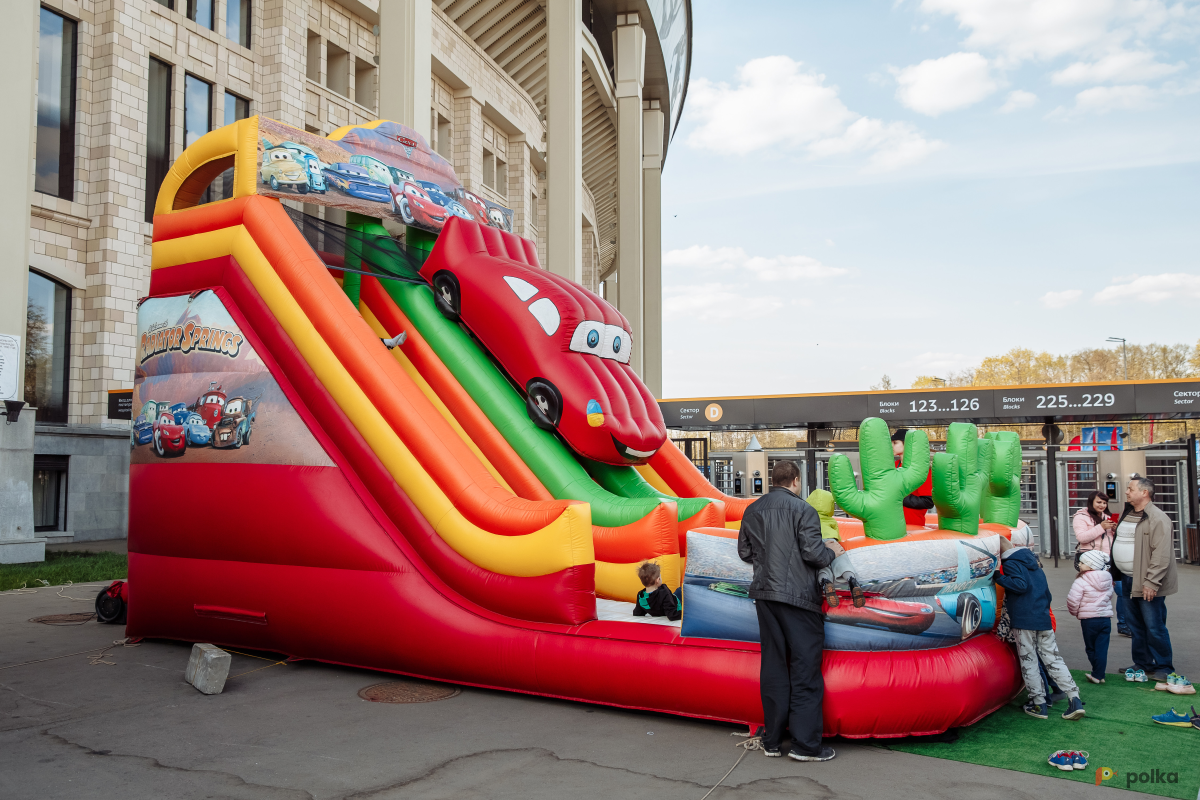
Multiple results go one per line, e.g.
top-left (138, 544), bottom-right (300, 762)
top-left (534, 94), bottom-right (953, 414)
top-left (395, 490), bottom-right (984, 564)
top-left (829, 416), bottom-right (929, 539)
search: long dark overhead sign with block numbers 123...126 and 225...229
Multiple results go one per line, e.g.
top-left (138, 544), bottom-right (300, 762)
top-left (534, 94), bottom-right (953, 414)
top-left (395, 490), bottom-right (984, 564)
top-left (659, 380), bottom-right (1200, 431)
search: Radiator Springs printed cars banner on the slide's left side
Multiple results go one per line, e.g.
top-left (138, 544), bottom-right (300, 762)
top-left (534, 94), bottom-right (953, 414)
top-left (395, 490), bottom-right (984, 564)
top-left (130, 290), bottom-right (334, 467)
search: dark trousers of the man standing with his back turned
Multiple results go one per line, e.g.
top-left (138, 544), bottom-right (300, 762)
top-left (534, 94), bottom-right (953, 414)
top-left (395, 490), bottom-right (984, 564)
top-left (755, 600), bottom-right (824, 756)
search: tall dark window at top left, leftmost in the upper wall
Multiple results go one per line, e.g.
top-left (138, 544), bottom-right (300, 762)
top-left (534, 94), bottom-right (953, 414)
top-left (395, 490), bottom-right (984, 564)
top-left (34, 8), bottom-right (76, 200)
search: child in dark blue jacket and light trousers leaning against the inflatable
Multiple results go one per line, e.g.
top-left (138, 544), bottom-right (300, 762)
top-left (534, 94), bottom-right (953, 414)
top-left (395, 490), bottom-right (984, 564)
top-left (996, 537), bottom-right (1086, 720)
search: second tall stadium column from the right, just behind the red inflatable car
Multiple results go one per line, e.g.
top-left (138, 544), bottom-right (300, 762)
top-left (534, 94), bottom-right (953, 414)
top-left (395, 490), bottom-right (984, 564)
top-left (612, 13), bottom-right (646, 375)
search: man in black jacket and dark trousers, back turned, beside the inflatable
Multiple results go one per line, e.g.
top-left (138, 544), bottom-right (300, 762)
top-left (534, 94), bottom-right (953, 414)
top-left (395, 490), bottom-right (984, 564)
top-left (738, 461), bottom-right (845, 762)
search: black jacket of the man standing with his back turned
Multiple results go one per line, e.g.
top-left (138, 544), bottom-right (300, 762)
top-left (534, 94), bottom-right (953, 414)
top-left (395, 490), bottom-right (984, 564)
top-left (738, 486), bottom-right (834, 613)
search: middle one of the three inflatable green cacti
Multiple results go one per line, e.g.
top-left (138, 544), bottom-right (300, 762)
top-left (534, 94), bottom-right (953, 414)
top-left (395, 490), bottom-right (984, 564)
top-left (934, 422), bottom-right (994, 536)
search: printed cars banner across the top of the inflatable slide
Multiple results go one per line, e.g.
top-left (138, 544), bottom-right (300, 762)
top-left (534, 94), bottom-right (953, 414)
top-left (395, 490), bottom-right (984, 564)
top-left (258, 118), bottom-right (512, 234)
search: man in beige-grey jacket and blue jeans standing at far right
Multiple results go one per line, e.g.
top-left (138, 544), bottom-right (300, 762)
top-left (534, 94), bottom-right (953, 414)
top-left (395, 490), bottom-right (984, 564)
top-left (1114, 477), bottom-right (1178, 681)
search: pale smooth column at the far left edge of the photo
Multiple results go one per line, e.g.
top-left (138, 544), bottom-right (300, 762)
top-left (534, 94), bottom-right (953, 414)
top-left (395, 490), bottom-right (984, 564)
top-left (0, 2), bottom-right (40, 400)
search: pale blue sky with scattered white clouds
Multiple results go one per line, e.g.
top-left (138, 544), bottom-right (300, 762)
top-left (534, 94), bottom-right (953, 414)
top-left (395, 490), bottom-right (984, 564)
top-left (662, 0), bottom-right (1200, 398)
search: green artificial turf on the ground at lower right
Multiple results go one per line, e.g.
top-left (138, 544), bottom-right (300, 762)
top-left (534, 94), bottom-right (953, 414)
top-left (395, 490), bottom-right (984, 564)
top-left (886, 670), bottom-right (1200, 800)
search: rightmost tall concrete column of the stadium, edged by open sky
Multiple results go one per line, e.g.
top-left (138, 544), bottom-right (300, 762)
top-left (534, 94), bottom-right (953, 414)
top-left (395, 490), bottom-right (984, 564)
top-left (642, 100), bottom-right (665, 397)
